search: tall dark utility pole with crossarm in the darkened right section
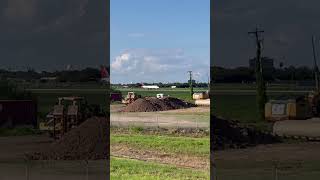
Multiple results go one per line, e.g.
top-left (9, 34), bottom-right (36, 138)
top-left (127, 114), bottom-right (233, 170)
top-left (248, 28), bottom-right (267, 120)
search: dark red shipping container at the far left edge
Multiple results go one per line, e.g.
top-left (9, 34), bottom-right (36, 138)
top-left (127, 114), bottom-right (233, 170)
top-left (0, 100), bottom-right (37, 128)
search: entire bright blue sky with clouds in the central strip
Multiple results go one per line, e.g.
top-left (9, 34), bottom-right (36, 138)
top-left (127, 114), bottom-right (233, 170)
top-left (110, 0), bottom-right (210, 83)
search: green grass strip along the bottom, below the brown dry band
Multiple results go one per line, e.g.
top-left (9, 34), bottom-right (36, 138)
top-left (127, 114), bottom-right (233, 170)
top-left (110, 158), bottom-right (209, 180)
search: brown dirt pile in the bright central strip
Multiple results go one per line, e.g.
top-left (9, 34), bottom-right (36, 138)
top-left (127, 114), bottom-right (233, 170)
top-left (123, 97), bottom-right (194, 112)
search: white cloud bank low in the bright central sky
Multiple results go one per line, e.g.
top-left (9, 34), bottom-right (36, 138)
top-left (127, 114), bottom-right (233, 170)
top-left (111, 49), bottom-right (209, 82)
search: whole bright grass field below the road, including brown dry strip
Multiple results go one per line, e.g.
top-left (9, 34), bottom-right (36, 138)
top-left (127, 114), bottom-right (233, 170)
top-left (110, 128), bottom-right (210, 179)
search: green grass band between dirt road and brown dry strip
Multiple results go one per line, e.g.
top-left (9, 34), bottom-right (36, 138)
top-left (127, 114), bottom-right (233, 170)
top-left (110, 132), bottom-right (210, 158)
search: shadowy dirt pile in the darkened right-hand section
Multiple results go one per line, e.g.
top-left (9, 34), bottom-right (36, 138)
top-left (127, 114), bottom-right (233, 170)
top-left (211, 116), bottom-right (280, 150)
